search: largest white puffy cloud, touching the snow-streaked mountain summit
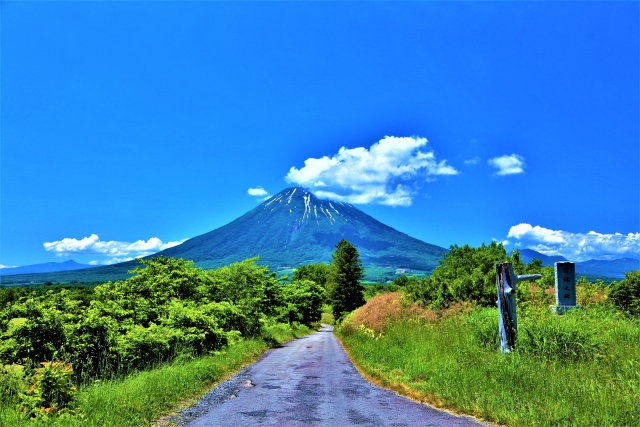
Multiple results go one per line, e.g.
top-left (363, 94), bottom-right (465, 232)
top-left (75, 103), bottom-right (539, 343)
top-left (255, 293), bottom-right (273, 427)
top-left (285, 136), bottom-right (458, 206)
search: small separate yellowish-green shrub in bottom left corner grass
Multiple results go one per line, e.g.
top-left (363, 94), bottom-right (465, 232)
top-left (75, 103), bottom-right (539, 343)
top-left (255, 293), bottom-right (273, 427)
top-left (20, 362), bottom-right (76, 417)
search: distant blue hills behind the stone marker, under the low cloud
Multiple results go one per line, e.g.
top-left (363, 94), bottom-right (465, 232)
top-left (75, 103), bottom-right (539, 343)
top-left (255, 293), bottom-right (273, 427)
top-left (520, 249), bottom-right (640, 281)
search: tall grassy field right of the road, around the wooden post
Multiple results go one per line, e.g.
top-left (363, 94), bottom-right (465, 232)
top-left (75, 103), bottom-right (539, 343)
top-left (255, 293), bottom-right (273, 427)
top-left (337, 293), bottom-right (640, 426)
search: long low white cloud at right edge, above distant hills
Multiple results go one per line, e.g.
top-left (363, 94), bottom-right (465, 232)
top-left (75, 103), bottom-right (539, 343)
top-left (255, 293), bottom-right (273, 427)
top-left (507, 224), bottom-right (640, 261)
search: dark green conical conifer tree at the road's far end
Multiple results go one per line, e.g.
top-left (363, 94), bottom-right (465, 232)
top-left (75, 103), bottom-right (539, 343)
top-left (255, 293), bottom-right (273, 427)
top-left (327, 239), bottom-right (365, 319)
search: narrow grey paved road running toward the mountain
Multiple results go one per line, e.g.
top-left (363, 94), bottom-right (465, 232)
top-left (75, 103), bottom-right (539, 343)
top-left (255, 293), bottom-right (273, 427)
top-left (178, 326), bottom-right (483, 427)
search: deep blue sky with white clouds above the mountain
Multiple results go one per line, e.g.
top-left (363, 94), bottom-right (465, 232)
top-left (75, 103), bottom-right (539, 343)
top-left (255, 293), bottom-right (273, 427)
top-left (0, 1), bottom-right (640, 266)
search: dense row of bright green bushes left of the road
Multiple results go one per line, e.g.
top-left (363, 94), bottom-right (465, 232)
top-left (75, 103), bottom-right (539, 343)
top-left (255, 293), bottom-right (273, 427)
top-left (0, 257), bottom-right (323, 390)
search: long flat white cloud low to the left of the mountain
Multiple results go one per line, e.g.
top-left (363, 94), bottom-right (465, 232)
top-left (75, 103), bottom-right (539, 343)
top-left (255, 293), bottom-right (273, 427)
top-left (43, 234), bottom-right (187, 264)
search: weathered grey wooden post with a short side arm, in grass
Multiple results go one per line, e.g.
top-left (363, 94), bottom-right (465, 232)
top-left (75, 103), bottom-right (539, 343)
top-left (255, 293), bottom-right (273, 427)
top-left (496, 262), bottom-right (542, 353)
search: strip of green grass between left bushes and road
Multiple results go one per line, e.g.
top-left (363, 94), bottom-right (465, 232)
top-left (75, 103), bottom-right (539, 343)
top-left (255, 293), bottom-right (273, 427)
top-left (0, 324), bottom-right (312, 427)
